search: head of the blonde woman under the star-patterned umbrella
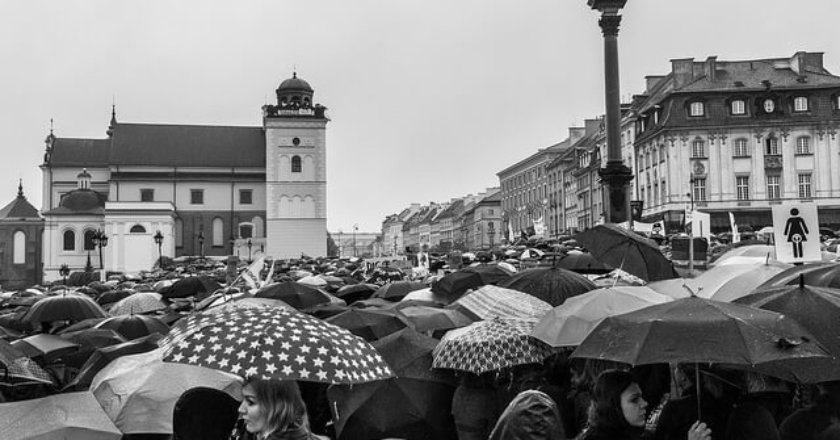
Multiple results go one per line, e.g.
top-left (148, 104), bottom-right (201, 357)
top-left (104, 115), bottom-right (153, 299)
top-left (239, 378), bottom-right (309, 435)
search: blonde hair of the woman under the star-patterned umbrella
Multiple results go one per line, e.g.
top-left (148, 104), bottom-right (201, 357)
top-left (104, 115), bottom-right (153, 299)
top-left (245, 378), bottom-right (309, 433)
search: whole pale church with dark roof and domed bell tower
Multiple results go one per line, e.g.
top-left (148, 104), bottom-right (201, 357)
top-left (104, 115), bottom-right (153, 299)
top-left (41, 74), bottom-right (329, 280)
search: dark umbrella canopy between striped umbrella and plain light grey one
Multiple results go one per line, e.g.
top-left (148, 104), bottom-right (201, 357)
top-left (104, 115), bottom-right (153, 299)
top-left (499, 267), bottom-right (597, 306)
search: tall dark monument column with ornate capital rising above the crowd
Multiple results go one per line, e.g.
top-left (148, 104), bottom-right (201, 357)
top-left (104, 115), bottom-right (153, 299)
top-left (587, 0), bottom-right (633, 223)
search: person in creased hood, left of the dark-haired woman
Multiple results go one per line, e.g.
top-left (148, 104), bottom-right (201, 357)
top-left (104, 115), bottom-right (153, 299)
top-left (490, 390), bottom-right (566, 440)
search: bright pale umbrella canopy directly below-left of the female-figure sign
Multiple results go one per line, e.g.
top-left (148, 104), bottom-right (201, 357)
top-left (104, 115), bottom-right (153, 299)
top-left (691, 262), bottom-right (790, 301)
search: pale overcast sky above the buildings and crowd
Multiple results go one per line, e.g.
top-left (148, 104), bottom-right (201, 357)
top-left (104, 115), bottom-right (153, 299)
top-left (0, 0), bottom-right (840, 231)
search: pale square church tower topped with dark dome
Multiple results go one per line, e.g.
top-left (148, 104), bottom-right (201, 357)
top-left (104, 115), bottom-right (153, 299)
top-left (263, 72), bottom-right (329, 258)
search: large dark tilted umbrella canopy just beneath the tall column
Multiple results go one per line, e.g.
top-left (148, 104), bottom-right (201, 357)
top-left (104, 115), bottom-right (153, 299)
top-left (575, 223), bottom-right (678, 281)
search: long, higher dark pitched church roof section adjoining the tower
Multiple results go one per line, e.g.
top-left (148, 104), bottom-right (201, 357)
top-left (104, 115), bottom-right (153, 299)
top-left (109, 124), bottom-right (265, 168)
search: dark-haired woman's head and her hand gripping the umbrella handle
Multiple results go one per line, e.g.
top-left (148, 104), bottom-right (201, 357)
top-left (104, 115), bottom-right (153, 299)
top-left (578, 370), bottom-right (712, 440)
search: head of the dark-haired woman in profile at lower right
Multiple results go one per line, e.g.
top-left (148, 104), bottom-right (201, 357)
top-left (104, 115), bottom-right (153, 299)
top-left (589, 370), bottom-right (647, 431)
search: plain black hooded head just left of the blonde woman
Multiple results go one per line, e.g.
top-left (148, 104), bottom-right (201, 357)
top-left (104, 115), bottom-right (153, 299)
top-left (172, 387), bottom-right (239, 440)
